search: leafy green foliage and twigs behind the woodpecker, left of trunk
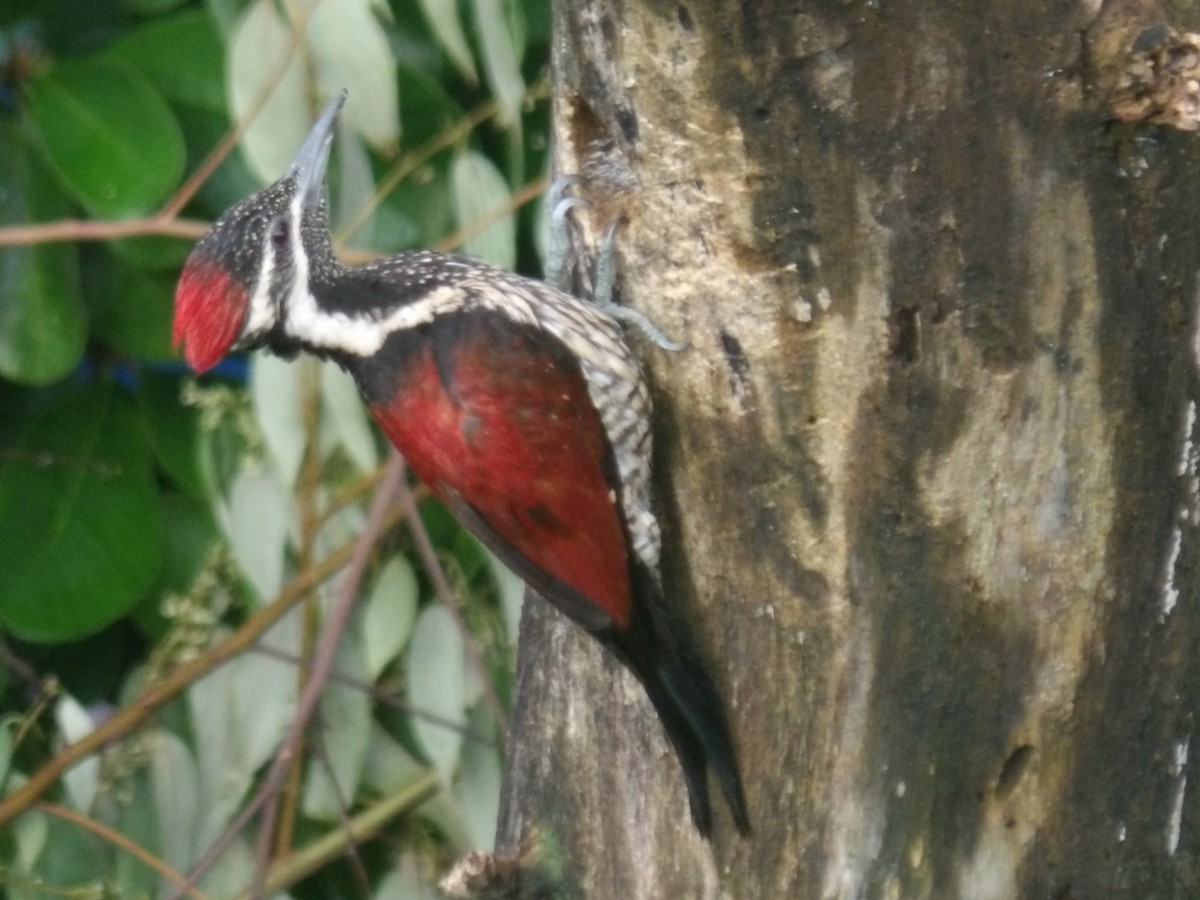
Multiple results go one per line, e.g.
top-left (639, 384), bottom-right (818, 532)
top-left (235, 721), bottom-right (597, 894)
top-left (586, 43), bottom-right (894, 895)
top-left (0, 0), bottom-right (548, 900)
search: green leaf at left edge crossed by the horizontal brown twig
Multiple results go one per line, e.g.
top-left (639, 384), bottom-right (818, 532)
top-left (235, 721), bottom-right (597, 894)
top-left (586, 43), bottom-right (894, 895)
top-left (0, 122), bottom-right (88, 385)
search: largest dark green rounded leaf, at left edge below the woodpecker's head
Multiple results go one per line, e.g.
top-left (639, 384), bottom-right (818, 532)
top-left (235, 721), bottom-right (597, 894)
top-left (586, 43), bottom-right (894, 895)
top-left (0, 386), bottom-right (163, 642)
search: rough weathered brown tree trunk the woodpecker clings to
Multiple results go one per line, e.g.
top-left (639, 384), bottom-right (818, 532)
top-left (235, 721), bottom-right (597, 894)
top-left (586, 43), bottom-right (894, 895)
top-left (498, 0), bottom-right (1200, 900)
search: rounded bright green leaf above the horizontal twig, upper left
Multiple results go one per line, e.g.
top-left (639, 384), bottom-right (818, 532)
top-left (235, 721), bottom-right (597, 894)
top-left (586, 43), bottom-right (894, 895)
top-left (26, 59), bottom-right (184, 218)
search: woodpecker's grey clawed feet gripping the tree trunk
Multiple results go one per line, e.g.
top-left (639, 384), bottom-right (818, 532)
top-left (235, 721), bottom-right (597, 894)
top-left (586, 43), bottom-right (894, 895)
top-left (546, 175), bottom-right (685, 352)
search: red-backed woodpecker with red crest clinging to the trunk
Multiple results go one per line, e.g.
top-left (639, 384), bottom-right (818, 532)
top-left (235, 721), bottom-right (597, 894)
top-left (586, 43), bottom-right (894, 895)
top-left (173, 91), bottom-right (750, 836)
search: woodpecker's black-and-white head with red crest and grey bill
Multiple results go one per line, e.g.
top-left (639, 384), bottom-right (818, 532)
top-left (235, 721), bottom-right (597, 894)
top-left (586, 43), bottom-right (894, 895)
top-left (174, 91), bottom-right (346, 372)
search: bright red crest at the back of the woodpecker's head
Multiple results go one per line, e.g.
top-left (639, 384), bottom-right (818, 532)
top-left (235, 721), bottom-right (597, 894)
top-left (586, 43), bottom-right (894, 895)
top-left (172, 253), bottom-right (247, 372)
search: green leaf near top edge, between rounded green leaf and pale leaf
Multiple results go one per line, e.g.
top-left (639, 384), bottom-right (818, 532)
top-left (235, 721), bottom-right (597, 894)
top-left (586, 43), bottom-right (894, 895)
top-left (104, 8), bottom-right (226, 114)
